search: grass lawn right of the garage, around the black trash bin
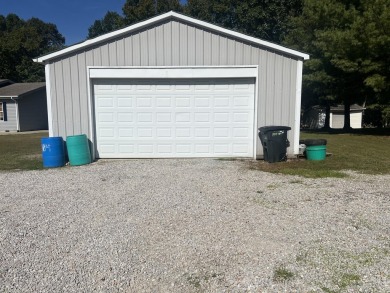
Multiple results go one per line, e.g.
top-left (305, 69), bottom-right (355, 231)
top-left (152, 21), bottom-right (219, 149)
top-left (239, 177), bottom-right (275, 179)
top-left (252, 130), bottom-right (390, 178)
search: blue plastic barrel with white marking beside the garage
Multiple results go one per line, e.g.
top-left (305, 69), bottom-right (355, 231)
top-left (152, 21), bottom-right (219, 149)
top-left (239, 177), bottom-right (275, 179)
top-left (41, 137), bottom-right (65, 168)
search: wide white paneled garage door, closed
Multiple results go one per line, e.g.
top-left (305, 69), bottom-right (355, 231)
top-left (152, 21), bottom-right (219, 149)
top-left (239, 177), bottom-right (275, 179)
top-left (94, 78), bottom-right (255, 158)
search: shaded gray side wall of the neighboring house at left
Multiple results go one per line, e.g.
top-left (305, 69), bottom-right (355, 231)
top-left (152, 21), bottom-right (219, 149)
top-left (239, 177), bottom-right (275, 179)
top-left (18, 89), bottom-right (48, 131)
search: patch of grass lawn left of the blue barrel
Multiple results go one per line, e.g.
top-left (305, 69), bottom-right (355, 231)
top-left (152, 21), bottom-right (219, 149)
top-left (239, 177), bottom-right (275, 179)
top-left (0, 132), bottom-right (48, 171)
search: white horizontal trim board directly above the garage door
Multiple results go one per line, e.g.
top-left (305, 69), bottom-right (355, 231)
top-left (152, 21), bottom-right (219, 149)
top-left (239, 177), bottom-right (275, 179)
top-left (88, 66), bottom-right (258, 79)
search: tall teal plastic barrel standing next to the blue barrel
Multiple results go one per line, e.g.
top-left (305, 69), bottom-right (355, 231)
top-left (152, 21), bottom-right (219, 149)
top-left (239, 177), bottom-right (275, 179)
top-left (66, 134), bottom-right (91, 166)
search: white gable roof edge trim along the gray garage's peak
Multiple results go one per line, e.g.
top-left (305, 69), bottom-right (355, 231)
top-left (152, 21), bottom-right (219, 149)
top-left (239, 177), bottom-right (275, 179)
top-left (34, 11), bottom-right (309, 63)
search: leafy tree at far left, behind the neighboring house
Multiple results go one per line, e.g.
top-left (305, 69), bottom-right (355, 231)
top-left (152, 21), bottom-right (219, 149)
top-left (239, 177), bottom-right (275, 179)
top-left (0, 14), bottom-right (65, 82)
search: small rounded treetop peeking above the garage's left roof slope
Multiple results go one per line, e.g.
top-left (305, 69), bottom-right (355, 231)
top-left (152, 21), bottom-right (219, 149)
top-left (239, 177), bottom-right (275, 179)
top-left (88, 11), bottom-right (124, 39)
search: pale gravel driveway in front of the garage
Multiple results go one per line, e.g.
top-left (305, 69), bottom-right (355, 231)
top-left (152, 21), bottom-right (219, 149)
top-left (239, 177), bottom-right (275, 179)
top-left (0, 159), bottom-right (390, 292)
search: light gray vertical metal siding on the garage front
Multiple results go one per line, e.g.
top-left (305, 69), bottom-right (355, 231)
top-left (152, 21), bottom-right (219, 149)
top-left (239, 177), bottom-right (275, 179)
top-left (46, 21), bottom-right (299, 154)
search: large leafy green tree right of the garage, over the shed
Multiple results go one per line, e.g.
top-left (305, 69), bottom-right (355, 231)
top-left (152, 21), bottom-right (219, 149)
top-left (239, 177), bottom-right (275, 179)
top-left (285, 0), bottom-right (390, 130)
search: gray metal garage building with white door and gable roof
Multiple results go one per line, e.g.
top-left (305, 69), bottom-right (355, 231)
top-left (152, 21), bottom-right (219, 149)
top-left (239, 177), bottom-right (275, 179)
top-left (35, 12), bottom-right (309, 158)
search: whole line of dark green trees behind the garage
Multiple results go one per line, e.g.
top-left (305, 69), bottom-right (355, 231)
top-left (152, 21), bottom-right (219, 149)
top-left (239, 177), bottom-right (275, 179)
top-left (0, 0), bottom-right (390, 129)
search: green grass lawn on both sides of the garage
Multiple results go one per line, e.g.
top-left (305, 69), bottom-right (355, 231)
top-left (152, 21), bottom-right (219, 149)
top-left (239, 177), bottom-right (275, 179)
top-left (0, 130), bottom-right (390, 178)
